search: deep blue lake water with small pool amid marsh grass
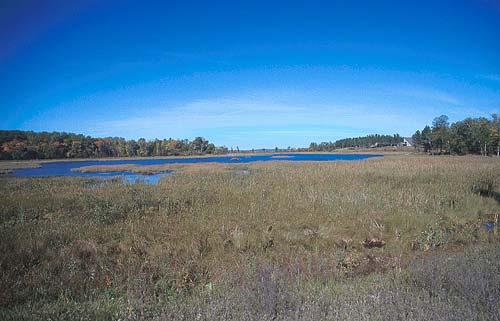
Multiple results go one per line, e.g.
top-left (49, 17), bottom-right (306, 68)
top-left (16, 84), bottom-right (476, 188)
top-left (12, 154), bottom-right (382, 184)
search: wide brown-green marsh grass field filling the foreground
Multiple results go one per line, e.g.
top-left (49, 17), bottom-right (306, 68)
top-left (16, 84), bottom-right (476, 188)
top-left (0, 156), bottom-right (500, 320)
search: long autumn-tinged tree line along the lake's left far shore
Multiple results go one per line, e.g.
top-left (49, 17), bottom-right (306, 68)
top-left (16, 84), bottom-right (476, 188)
top-left (0, 130), bottom-right (228, 160)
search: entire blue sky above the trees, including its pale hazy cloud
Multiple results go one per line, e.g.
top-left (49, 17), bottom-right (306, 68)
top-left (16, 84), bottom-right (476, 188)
top-left (0, 0), bottom-right (500, 148)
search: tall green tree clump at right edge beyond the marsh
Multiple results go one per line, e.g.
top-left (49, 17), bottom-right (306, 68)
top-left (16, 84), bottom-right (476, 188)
top-left (413, 114), bottom-right (500, 156)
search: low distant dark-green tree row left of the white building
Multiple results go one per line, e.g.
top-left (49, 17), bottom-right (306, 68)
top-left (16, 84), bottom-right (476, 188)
top-left (309, 134), bottom-right (403, 152)
